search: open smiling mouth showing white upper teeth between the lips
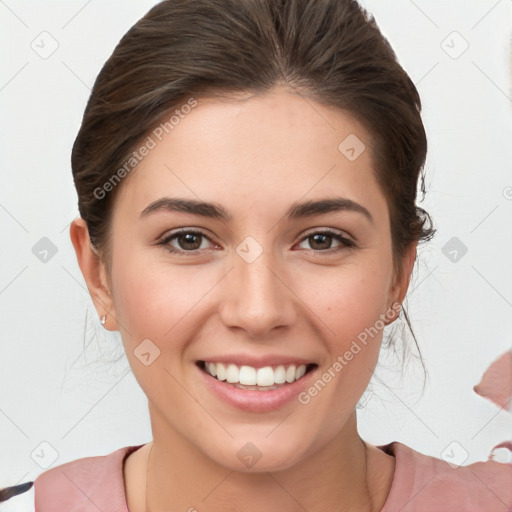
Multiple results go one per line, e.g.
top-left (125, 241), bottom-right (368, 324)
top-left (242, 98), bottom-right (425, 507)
top-left (196, 361), bottom-right (318, 391)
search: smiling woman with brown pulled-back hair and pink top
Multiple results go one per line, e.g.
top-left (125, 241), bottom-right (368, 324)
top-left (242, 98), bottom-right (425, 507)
top-left (2, 0), bottom-right (512, 512)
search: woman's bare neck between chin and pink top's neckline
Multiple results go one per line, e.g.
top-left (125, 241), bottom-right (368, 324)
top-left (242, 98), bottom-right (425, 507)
top-left (146, 412), bottom-right (380, 512)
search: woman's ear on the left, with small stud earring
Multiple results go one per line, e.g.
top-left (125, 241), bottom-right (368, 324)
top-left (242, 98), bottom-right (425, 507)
top-left (69, 217), bottom-right (118, 330)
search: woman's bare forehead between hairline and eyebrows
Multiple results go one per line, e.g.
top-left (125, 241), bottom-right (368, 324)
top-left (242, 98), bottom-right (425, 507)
top-left (111, 88), bottom-right (383, 224)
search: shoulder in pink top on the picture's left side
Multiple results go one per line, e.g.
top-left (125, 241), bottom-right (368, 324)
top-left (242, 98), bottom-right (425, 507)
top-left (34, 445), bottom-right (143, 512)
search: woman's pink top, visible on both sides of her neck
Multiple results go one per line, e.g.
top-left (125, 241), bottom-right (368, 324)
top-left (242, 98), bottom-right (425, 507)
top-left (34, 441), bottom-right (512, 512)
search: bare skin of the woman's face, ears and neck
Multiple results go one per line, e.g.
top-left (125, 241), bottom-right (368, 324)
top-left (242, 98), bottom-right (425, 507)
top-left (70, 87), bottom-right (416, 512)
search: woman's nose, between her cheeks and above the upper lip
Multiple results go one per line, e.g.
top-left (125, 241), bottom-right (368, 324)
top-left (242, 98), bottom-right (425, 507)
top-left (220, 245), bottom-right (298, 339)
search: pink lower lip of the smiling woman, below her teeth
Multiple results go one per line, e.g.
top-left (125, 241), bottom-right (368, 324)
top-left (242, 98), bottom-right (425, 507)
top-left (196, 365), bottom-right (317, 412)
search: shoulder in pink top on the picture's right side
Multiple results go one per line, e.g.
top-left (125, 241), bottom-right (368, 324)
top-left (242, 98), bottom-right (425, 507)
top-left (378, 441), bottom-right (512, 512)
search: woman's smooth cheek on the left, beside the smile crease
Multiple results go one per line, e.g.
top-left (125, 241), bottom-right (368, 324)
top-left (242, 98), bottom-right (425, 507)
top-left (112, 251), bottom-right (203, 402)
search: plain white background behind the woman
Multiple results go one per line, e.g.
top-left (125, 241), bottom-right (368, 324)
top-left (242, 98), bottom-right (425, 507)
top-left (0, 0), bottom-right (512, 504)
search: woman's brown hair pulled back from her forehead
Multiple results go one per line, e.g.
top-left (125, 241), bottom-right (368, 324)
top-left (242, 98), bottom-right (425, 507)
top-left (71, 0), bottom-right (435, 376)
